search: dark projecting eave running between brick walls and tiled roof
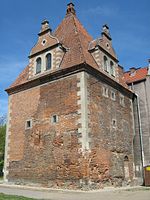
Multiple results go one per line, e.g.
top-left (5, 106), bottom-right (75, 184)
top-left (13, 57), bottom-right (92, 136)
top-left (5, 63), bottom-right (133, 98)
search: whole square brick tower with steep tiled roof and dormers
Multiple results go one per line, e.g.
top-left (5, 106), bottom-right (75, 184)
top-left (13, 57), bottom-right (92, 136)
top-left (5, 3), bottom-right (138, 189)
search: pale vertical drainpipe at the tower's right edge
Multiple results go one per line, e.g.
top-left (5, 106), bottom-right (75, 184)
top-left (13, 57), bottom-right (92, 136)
top-left (135, 93), bottom-right (144, 184)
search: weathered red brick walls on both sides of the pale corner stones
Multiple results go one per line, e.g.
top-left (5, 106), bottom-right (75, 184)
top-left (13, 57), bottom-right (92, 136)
top-left (7, 72), bottom-right (133, 189)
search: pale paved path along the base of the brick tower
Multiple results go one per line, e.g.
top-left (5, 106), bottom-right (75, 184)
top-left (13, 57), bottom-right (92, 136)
top-left (0, 184), bottom-right (150, 200)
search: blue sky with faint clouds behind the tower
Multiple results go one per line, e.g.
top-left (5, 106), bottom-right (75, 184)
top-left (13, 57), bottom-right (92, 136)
top-left (0, 0), bottom-right (150, 116)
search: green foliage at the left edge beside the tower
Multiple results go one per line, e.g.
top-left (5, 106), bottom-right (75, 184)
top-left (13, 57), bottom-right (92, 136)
top-left (0, 125), bottom-right (6, 176)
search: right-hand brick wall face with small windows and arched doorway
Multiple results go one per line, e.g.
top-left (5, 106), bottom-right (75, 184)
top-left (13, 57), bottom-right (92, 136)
top-left (88, 76), bottom-right (134, 188)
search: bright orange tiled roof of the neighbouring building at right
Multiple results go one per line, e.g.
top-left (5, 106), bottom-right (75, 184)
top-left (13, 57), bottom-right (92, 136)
top-left (123, 67), bottom-right (148, 84)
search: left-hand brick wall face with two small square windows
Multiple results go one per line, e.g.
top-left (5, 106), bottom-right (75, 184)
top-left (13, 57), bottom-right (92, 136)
top-left (8, 75), bottom-right (83, 187)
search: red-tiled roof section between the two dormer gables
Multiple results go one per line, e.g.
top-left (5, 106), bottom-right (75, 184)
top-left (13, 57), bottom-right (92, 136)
top-left (54, 14), bottom-right (98, 68)
